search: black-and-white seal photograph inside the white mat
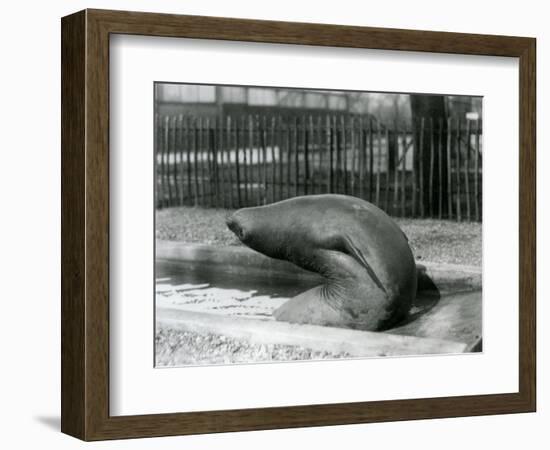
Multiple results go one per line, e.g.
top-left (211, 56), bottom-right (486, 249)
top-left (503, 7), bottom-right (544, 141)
top-left (151, 81), bottom-right (483, 368)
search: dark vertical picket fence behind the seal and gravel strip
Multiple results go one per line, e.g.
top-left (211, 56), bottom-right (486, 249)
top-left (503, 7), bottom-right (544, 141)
top-left (155, 114), bottom-right (482, 221)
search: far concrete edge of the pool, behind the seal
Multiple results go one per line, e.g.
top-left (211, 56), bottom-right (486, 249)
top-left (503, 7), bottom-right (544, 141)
top-left (155, 239), bottom-right (482, 288)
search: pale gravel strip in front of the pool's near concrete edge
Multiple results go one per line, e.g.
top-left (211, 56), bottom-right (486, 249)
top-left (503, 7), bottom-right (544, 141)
top-left (155, 329), bottom-right (350, 367)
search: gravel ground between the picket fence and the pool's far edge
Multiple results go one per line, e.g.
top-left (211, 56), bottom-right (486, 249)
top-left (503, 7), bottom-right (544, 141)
top-left (156, 207), bottom-right (481, 266)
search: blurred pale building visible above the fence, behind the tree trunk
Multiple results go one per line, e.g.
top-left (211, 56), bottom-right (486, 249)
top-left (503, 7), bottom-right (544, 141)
top-left (155, 83), bottom-right (482, 127)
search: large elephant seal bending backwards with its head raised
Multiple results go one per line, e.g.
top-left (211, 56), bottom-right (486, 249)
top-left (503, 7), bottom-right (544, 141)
top-left (226, 194), bottom-right (417, 331)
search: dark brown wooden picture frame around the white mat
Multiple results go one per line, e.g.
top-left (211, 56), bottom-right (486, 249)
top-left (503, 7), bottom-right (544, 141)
top-left (61, 10), bottom-right (536, 440)
